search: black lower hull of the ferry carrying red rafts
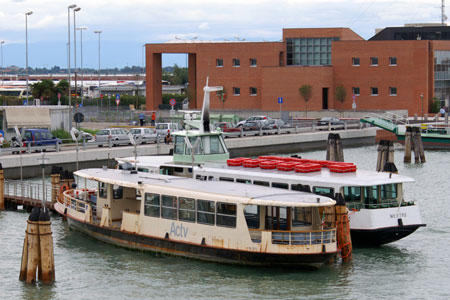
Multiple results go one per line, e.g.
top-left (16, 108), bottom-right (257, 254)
top-left (350, 224), bottom-right (425, 246)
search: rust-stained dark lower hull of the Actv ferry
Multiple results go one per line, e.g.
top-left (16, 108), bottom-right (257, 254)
top-left (57, 209), bottom-right (337, 269)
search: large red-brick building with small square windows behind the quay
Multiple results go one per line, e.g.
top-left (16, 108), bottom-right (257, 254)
top-left (146, 28), bottom-right (450, 115)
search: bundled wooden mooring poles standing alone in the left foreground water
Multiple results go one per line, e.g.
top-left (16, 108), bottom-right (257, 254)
top-left (19, 207), bottom-right (55, 284)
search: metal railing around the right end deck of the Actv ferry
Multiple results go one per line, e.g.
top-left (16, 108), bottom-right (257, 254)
top-left (250, 228), bottom-right (336, 245)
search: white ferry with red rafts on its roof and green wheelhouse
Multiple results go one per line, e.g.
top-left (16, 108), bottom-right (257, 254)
top-left (117, 78), bottom-right (425, 245)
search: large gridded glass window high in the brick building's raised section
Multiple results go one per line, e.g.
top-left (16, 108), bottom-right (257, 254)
top-left (286, 37), bottom-right (339, 66)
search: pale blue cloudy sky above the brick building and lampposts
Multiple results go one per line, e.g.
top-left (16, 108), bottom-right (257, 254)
top-left (0, 0), bottom-right (444, 68)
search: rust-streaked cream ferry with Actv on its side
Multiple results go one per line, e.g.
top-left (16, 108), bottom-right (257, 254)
top-left (55, 168), bottom-right (339, 268)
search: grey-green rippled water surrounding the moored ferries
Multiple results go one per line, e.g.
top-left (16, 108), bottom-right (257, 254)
top-left (0, 146), bottom-right (450, 299)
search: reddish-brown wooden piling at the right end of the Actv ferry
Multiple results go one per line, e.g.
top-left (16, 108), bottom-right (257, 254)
top-left (335, 199), bottom-right (352, 263)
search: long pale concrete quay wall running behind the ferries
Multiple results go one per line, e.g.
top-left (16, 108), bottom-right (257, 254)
top-left (1, 128), bottom-right (377, 179)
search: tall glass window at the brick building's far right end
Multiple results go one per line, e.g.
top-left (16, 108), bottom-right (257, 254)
top-left (434, 51), bottom-right (450, 106)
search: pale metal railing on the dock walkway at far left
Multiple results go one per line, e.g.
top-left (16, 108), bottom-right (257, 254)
top-left (4, 179), bottom-right (59, 203)
